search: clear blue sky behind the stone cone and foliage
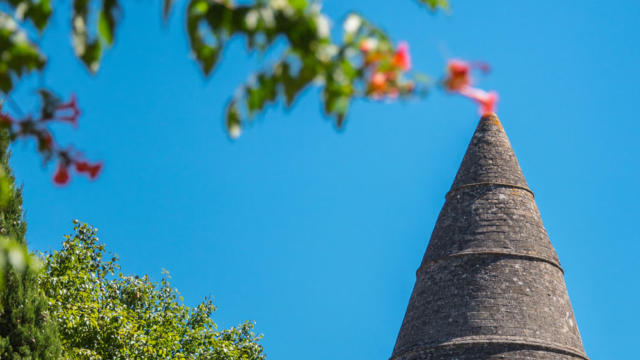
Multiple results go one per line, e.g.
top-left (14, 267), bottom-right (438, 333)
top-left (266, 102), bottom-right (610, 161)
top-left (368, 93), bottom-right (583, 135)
top-left (6, 0), bottom-right (640, 360)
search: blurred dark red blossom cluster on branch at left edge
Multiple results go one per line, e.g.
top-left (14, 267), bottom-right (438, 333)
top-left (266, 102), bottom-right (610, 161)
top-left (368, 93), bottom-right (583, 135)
top-left (0, 89), bottom-right (102, 185)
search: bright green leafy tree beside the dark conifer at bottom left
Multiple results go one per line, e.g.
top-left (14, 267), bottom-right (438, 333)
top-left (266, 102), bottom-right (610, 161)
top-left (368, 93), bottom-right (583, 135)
top-left (40, 221), bottom-right (265, 360)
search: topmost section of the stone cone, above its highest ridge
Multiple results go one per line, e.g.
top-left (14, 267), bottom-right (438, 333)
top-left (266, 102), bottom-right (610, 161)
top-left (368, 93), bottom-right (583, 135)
top-left (451, 113), bottom-right (529, 191)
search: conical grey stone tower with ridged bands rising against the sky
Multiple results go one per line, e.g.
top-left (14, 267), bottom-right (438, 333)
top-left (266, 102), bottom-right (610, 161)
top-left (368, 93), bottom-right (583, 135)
top-left (391, 115), bottom-right (588, 360)
